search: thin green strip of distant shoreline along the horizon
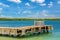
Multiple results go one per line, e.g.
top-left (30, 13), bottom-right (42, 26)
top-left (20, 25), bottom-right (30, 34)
top-left (0, 18), bottom-right (60, 21)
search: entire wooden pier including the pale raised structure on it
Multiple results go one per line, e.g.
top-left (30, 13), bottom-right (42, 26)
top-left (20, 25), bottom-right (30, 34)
top-left (0, 21), bottom-right (53, 36)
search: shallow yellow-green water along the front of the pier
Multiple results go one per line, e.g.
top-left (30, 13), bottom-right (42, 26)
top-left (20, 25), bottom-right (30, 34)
top-left (0, 32), bottom-right (53, 40)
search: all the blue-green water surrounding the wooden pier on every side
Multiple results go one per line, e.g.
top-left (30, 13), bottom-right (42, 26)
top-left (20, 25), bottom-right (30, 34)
top-left (0, 20), bottom-right (60, 40)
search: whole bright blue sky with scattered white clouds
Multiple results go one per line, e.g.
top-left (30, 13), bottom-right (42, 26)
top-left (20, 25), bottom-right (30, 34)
top-left (0, 0), bottom-right (60, 18)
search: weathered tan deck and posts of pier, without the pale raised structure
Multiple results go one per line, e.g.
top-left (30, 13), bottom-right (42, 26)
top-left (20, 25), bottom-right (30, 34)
top-left (0, 25), bottom-right (53, 36)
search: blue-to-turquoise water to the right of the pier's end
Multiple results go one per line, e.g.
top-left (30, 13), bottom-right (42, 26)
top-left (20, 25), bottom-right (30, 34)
top-left (45, 20), bottom-right (60, 40)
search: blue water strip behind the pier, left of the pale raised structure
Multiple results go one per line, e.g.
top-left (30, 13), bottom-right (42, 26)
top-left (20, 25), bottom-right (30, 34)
top-left (0, 20), bottom-right (34, 27)
